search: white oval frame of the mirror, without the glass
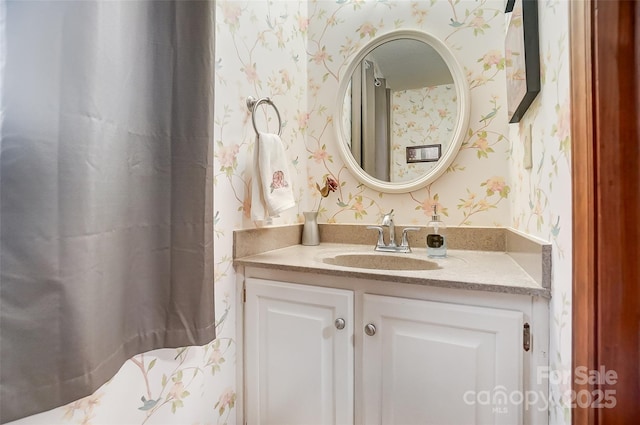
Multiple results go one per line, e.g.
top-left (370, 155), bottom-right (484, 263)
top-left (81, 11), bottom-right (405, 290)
top-left (333, 30), bottom-right (471, 193)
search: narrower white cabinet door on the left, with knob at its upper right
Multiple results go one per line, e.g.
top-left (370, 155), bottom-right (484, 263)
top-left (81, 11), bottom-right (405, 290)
top-left (245, 279), bottom-right (354, 425)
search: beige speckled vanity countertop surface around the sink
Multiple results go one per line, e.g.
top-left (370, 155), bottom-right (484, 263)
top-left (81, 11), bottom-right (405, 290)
top-left (234, 243), bottom-right (550, 298)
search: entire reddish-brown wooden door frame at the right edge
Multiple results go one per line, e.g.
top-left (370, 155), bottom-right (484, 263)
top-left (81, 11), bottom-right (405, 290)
top-left (569, 0), bottom-right (640, 425)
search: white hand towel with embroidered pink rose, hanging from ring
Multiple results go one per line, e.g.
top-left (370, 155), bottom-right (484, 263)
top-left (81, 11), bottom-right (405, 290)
top-left (251, 133), bottom-right (296, 220)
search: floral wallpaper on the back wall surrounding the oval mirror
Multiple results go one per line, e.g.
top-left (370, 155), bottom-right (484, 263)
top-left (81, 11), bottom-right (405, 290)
top-left (305, 0), bottom-right (511, 226)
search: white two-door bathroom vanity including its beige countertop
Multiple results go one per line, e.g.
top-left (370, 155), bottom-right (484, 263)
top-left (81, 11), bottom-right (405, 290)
top-left (235, 226), bottom-right (550, 425)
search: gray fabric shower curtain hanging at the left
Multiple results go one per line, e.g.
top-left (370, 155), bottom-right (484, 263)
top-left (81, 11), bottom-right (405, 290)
top-left (0, 0), bottom-right (215, 422)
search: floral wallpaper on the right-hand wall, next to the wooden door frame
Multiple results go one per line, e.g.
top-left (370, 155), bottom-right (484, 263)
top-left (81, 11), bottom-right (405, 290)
top-left (509, 0), bottom-right (572, 424)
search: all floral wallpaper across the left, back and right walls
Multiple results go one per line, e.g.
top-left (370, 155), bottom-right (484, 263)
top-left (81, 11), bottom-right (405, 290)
top-left (8, 0), bottom-right (571, 425)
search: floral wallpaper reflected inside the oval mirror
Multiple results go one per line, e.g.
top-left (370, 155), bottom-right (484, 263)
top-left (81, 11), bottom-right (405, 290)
top-left (391, 84), bottom-right (458, 182)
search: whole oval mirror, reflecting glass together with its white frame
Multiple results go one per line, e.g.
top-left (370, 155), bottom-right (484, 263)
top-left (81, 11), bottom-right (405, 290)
top-left (335, 30), bottom-right (470, 192)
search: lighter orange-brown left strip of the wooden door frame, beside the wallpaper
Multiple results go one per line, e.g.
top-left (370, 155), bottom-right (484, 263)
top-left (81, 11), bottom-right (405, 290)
top-left (569, 1), bottom-right (596, 424)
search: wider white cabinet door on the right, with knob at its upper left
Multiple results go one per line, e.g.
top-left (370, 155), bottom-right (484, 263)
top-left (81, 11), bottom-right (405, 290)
top-left (362, 294), bottom-right (523, 425)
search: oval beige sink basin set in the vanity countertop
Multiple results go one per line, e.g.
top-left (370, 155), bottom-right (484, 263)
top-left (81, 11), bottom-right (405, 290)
top-left (322, 253), bottom-right (440, 270)
